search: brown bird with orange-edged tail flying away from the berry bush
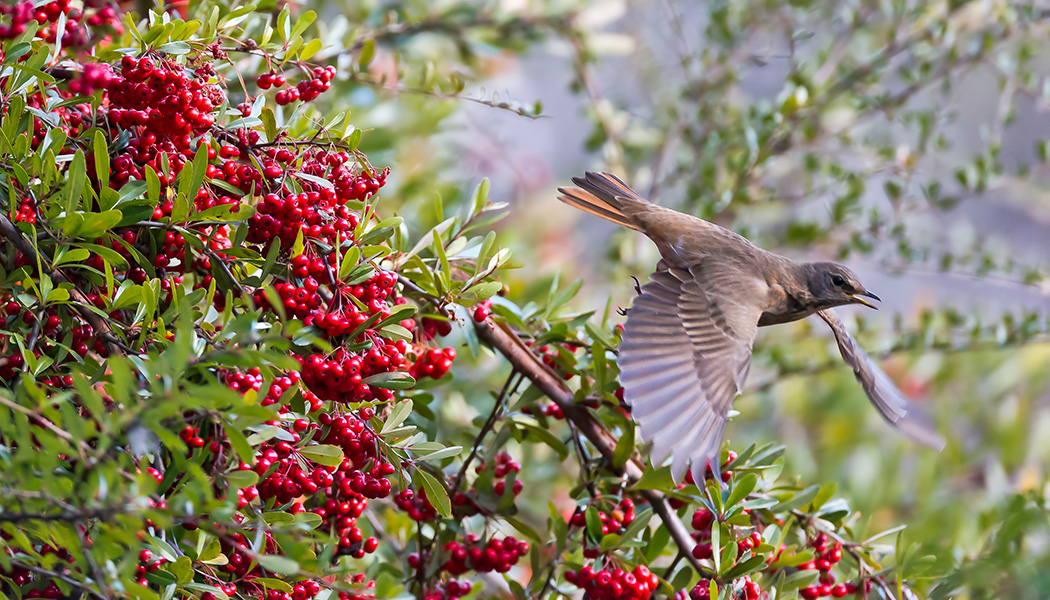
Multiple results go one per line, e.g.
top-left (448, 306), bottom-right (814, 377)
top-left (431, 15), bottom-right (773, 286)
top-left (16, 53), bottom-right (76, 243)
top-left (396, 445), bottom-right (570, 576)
top-left (559, 172), bottom-right (944, 482)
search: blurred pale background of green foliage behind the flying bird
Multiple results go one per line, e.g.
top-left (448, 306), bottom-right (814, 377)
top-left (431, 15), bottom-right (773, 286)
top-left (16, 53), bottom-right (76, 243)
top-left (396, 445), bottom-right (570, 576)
top-left (291, 0), bottom-right (1050, 598)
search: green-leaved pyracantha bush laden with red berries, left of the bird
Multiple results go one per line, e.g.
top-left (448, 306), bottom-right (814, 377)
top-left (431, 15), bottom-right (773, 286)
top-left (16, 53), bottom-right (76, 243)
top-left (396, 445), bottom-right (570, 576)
top-left (0, 1), bottom-right (991, 600)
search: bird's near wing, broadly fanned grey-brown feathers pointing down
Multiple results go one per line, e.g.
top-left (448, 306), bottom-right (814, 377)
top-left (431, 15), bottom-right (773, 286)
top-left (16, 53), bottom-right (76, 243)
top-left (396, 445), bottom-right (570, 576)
top-left (620, 257), bottom-right (768, 482)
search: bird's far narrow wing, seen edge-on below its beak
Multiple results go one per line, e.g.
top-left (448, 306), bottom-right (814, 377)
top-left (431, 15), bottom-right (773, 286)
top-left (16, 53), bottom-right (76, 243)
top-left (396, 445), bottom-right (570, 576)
top-left (817, 310), bottom-right (944, 450)
